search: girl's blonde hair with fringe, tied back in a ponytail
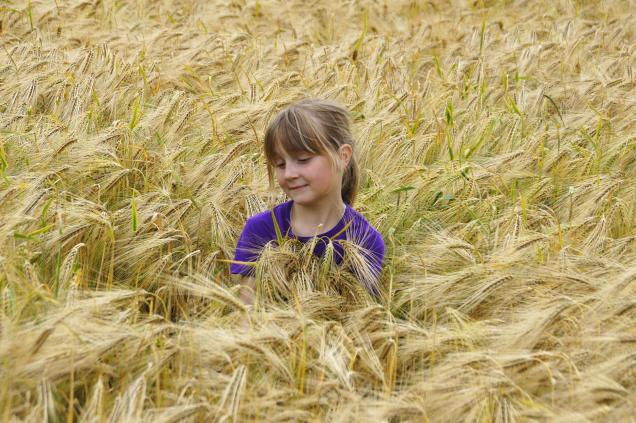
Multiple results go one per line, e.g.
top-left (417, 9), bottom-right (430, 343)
top-left (265, 99), bottom-right (359, 205)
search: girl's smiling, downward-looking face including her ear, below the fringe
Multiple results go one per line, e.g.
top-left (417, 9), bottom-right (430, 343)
top-left (274, 145), bottom-right (351, 206)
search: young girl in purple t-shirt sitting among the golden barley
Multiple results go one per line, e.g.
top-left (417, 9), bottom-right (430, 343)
top-left (230, 100), bottom-right (384, 304)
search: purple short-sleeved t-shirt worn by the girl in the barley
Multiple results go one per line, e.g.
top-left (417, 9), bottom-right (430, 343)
top-left (230, 200), bottom-right (384, 295)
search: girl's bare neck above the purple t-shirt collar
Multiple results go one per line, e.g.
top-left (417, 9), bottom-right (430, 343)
top-left (290, 200), bottom-right (346, 237)
